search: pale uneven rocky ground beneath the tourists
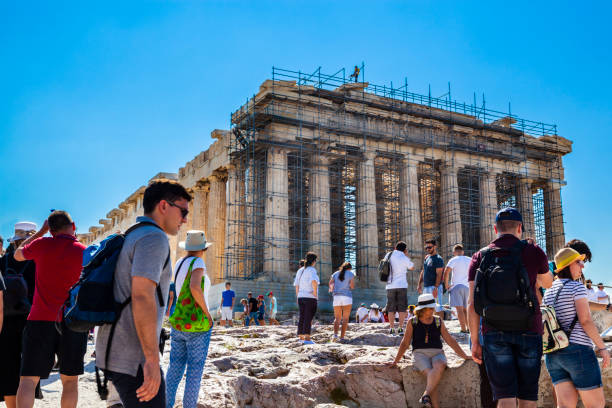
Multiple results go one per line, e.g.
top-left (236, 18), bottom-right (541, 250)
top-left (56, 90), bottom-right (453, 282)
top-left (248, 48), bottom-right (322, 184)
top-left (36, 318), bottom-right (612, 408)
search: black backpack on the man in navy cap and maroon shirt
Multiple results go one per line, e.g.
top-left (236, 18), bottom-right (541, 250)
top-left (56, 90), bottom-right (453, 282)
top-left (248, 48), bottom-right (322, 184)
top-left (474, 241), bottom-right (538, 331)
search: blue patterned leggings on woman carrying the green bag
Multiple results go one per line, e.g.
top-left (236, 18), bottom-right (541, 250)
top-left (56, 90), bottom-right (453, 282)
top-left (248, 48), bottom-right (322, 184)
top-left (166, 329), bottom-right (212, 408)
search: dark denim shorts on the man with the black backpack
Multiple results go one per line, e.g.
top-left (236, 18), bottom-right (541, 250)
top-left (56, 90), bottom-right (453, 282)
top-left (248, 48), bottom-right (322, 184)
top-left (482, 331), bottom-right (542, 401)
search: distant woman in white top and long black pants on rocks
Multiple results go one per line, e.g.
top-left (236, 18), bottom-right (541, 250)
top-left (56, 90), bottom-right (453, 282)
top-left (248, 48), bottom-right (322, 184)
top-left (293, 252), bottom-right (320, 344)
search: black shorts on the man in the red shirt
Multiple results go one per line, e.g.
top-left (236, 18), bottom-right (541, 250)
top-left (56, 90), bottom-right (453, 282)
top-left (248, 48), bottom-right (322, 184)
top-left (21, 320), bottom-right (87, 379)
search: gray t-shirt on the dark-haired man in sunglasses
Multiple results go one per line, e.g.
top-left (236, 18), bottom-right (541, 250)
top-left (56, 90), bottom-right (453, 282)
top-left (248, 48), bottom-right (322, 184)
top-left (96, 217), bottom-right (172, 377)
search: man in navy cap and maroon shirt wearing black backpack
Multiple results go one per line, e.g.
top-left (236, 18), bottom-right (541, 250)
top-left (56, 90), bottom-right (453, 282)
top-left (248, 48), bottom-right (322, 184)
top-left (468, 208), bottom-right (553, 408)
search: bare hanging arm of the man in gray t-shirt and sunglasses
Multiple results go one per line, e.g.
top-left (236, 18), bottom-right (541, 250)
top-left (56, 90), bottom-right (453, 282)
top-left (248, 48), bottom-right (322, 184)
top-left (132, 276), bottom-right (161, 402)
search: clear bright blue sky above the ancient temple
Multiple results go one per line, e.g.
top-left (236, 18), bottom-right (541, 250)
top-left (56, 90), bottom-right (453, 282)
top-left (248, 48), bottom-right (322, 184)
top-left (0, 1), bottom-right (612, 290)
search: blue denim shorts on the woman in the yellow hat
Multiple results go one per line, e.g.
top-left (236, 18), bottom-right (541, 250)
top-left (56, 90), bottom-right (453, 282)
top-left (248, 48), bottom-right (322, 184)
top-left (546, 343), bottom-right (603, 391)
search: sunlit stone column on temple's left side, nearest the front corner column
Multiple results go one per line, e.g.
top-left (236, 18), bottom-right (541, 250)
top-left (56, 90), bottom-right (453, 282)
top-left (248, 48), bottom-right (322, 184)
top-left (223, 164), bottom-right (245, 276)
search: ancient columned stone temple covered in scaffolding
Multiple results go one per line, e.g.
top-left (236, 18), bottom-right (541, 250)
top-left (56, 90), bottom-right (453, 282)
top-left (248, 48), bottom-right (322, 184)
top-left (81, 68), bottom-right (572, 302)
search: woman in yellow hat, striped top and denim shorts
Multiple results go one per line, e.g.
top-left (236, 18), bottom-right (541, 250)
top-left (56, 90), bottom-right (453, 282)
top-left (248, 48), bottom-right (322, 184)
top-left (543, 248), bottom-right (610, 408)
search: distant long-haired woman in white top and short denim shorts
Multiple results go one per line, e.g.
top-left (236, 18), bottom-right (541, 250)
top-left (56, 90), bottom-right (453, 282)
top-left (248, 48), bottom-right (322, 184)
top-left (329, 262), bottom-right (355, 340)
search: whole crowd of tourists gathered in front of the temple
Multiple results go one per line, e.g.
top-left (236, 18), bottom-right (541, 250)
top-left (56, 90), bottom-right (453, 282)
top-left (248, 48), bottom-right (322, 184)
top-left (0, 178), bottom-right (610, 408)
